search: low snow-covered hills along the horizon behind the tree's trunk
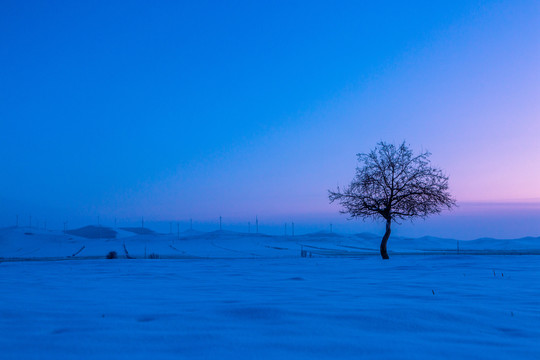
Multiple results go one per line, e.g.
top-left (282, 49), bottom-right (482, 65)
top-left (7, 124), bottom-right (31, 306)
top-left (0, 226), bottom-right (540, 259)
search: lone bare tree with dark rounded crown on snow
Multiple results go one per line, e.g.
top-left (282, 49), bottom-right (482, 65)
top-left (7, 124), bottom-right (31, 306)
top-left (328, 142), bottom-right (456, 259)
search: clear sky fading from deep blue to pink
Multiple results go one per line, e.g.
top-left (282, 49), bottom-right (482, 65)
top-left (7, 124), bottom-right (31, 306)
top-left (0, 0), bottom-right (540, 238)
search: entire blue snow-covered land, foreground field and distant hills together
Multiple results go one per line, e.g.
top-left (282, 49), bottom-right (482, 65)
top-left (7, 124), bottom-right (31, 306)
top-left (0, 228), bottom-right (540, 359)
